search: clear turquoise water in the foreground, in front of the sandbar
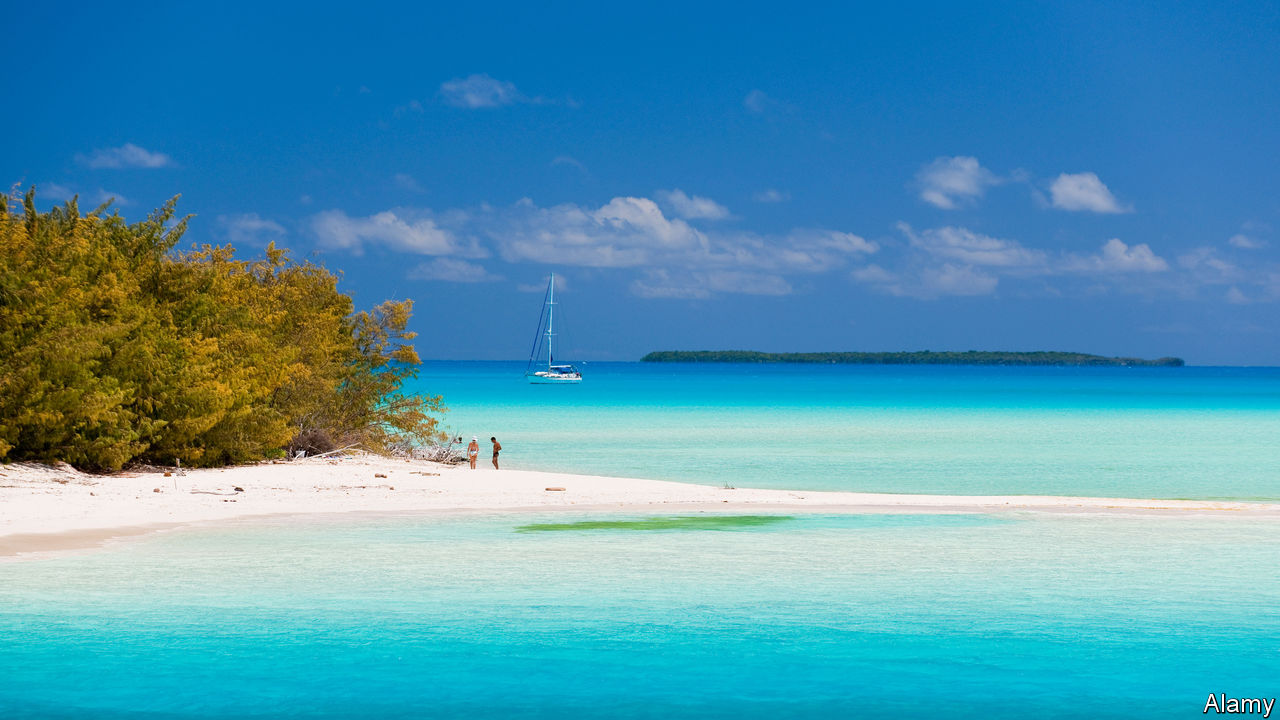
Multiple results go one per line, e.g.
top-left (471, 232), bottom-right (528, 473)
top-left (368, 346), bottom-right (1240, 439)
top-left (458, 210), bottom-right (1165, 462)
top-left (0, 512), bottom-right (1280, 717)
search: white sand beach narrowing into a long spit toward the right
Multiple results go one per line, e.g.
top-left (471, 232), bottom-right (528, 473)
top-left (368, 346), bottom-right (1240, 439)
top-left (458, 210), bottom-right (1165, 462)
top-left (0, 456), bottom-right (1280, 557)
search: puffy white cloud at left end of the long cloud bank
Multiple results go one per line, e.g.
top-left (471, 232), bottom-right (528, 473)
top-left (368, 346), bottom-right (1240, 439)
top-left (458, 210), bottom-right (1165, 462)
top-left (311, 210), bottom-right (477, 256)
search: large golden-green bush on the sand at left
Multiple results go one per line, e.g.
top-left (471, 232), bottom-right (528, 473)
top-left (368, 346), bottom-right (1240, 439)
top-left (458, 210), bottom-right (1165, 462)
top-left (0, 188), bottom-right (443, 470)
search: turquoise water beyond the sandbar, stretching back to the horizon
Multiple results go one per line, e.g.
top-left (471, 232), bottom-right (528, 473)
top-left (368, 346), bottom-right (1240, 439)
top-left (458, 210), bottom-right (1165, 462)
top-left (412, 363), bottom-right (1280, 500)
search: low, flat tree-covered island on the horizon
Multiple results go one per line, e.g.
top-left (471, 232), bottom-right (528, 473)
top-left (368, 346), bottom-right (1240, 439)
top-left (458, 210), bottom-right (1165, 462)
top-left (640, 350), bottom-right (1185, 368)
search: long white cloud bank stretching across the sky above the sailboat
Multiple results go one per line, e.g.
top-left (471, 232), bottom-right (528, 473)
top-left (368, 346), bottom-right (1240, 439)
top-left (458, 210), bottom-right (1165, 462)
top-left (308, 191), bottom-right (879, 299)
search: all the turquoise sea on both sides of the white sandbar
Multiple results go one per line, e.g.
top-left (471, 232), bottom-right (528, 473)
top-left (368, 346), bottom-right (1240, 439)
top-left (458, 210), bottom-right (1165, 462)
top-left (0, 364), bottom-right (1280, 719)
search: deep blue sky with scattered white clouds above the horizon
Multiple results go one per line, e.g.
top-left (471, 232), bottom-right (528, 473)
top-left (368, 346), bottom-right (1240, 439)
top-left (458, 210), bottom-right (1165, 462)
top-left (10, 3), bottom-right (1280, 365)
